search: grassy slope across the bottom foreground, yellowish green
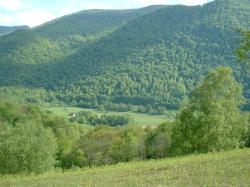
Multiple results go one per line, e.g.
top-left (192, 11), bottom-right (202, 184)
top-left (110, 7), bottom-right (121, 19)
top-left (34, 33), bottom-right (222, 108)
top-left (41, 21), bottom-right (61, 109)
top-left (0, 149), bottom-right (250, 187)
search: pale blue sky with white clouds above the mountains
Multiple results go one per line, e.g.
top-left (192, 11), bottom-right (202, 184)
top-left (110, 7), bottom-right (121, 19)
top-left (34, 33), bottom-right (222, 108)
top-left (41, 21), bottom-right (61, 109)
top-left (0, 0), bottom-right (211, 27)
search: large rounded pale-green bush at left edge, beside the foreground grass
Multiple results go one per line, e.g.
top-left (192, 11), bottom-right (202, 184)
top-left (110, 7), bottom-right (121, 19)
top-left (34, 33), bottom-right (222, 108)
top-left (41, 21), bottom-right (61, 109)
top-left (0, 123), bottom-right (56, 174)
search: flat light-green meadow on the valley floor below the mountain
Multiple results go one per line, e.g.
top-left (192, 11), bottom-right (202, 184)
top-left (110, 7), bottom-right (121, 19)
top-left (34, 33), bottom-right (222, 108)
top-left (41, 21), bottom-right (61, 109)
top-left (45, 107), bottom-right (174, 126)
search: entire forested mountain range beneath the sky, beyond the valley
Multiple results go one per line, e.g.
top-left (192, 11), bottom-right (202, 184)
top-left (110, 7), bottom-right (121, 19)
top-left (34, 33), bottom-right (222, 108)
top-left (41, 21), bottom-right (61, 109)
top-left (0, 0), bottom-right (250, 108)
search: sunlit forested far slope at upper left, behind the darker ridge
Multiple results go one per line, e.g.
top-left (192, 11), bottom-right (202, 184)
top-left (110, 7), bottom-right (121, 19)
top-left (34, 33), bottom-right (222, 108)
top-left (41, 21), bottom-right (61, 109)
top-left (0, 6), bottom-right (165, 64)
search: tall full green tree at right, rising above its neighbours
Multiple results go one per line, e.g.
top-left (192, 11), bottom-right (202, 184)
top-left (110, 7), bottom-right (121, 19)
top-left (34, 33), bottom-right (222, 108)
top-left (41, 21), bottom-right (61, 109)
top-left (172, 67), bottom-right (247, 154)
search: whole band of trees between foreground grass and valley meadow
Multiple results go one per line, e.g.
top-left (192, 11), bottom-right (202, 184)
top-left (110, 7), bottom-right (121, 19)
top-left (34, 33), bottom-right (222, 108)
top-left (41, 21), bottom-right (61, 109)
top-left (0, 67), bottom-right (250, 174)
